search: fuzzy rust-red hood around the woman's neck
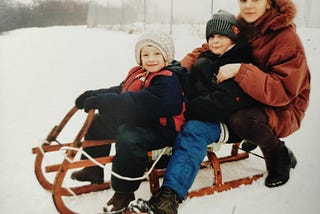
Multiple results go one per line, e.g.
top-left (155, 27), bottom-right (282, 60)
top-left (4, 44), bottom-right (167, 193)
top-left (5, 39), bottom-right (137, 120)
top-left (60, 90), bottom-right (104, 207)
top-left (238, 0), bottom-right (296, 32)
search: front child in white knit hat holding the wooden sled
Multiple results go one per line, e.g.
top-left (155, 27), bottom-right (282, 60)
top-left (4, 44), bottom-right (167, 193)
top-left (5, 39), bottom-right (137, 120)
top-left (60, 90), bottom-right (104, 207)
top-left (71, 33), bottom-right (185, 212)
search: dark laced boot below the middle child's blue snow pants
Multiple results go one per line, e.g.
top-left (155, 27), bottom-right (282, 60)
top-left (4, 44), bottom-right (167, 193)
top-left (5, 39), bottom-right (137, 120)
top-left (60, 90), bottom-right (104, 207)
top-left (129, 187), bottom-right (179, 214)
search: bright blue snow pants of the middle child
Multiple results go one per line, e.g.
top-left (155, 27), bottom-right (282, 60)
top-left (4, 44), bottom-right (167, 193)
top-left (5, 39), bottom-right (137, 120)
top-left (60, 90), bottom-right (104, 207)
top-left (162, 120), bottom-right (220, 201)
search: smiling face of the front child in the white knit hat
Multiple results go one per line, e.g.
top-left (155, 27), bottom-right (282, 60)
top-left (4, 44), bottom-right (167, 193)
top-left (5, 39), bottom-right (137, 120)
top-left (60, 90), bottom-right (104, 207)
top-left (141, 45), bottom-right (166, 72)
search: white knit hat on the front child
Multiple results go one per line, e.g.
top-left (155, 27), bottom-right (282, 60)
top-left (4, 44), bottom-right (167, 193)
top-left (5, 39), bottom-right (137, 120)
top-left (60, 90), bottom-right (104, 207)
top-left (135, 32), bottom-right (174, 65)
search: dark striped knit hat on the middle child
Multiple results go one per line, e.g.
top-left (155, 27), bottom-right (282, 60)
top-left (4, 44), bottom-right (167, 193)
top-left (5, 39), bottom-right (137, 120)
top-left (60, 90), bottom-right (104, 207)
top-left (206, 10), bottom-right (239, 41)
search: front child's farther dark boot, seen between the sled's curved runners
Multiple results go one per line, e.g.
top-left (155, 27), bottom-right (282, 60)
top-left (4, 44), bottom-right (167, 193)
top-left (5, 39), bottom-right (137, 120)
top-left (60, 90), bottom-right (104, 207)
top-left (71, 166), bottom-right (104, 184)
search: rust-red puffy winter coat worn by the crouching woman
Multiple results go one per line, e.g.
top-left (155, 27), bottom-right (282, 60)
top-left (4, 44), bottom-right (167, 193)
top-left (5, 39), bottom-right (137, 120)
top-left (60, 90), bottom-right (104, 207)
top-left (181, 0), bottom-right (310, 138)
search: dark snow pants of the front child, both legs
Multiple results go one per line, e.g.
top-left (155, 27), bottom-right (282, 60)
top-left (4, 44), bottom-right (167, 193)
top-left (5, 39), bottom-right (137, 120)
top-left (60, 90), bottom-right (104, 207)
top-left (82, 114), bottom-right (177, 192)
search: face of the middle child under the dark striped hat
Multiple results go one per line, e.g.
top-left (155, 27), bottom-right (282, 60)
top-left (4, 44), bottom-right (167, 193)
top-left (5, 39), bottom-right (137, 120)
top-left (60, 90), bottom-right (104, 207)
top-left (208, 34), bottom-right (234, 55)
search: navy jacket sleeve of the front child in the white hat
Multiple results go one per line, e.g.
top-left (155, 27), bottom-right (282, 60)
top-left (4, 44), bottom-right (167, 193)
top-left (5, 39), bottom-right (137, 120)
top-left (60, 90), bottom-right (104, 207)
top-left (97, 75), bottom-right (182, 119)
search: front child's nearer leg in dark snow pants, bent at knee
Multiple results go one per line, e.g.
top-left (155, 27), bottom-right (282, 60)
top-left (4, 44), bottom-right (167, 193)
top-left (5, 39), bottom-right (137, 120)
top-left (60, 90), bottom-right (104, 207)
top-left (111, 124), bottom-right (176, 192)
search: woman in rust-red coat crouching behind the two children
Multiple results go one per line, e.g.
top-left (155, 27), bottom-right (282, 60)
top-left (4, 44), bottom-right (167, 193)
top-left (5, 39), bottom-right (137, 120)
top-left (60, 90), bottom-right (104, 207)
top-left (181, 0), bottom-right (310, 187)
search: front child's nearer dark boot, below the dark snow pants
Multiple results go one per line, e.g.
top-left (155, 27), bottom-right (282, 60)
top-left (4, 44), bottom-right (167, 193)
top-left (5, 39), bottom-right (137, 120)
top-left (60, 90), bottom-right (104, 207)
top-left (103, 192), bottom-right (135, 213)
